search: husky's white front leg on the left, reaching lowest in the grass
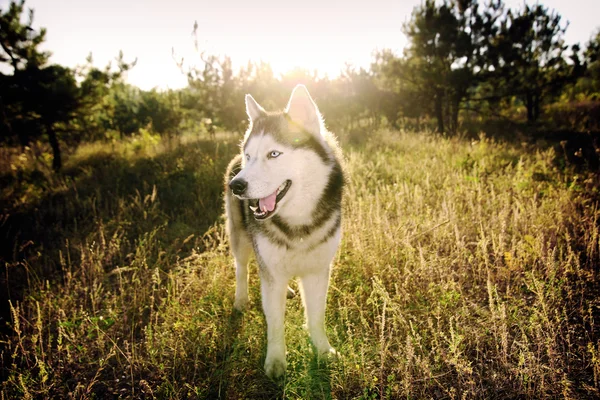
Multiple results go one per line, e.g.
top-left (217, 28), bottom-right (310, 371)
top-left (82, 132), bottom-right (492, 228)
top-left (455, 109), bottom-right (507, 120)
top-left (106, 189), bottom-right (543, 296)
top-left (260, 273), bottom-right (287, 378)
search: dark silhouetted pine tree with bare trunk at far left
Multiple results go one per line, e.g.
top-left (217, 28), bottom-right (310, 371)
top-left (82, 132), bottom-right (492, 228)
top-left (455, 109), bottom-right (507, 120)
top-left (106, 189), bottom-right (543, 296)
top-left (0, 1), bottom-right (77, 170)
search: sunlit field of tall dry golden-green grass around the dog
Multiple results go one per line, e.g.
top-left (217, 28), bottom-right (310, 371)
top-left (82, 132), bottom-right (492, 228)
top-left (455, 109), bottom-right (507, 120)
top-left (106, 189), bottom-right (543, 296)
top-left (0, 132), bottom-right (600, 400)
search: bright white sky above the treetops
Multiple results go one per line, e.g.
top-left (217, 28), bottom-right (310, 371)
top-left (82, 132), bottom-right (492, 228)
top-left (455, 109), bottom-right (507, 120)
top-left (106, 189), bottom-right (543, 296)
top-left (0, 0), bottom-right (600, 89)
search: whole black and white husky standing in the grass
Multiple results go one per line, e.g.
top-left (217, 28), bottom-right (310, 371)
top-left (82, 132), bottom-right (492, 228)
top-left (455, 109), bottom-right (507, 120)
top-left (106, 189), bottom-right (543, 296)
top-left (225, 85), bottom-right (344, 378)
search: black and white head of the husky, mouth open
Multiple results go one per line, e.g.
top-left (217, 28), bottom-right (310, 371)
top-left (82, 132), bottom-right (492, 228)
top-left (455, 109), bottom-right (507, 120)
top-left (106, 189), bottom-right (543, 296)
top-left (229, 85), bottom-right (333, 220)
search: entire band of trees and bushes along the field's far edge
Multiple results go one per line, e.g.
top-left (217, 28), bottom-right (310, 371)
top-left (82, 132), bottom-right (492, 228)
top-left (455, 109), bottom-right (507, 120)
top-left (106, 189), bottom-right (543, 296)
top-left (0, 0), bottom-right (600, 175)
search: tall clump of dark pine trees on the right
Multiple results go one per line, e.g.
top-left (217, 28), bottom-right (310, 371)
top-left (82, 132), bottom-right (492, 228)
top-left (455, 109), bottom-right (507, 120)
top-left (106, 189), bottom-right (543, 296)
top-left (373, 0), bottom-right (593, 133)
